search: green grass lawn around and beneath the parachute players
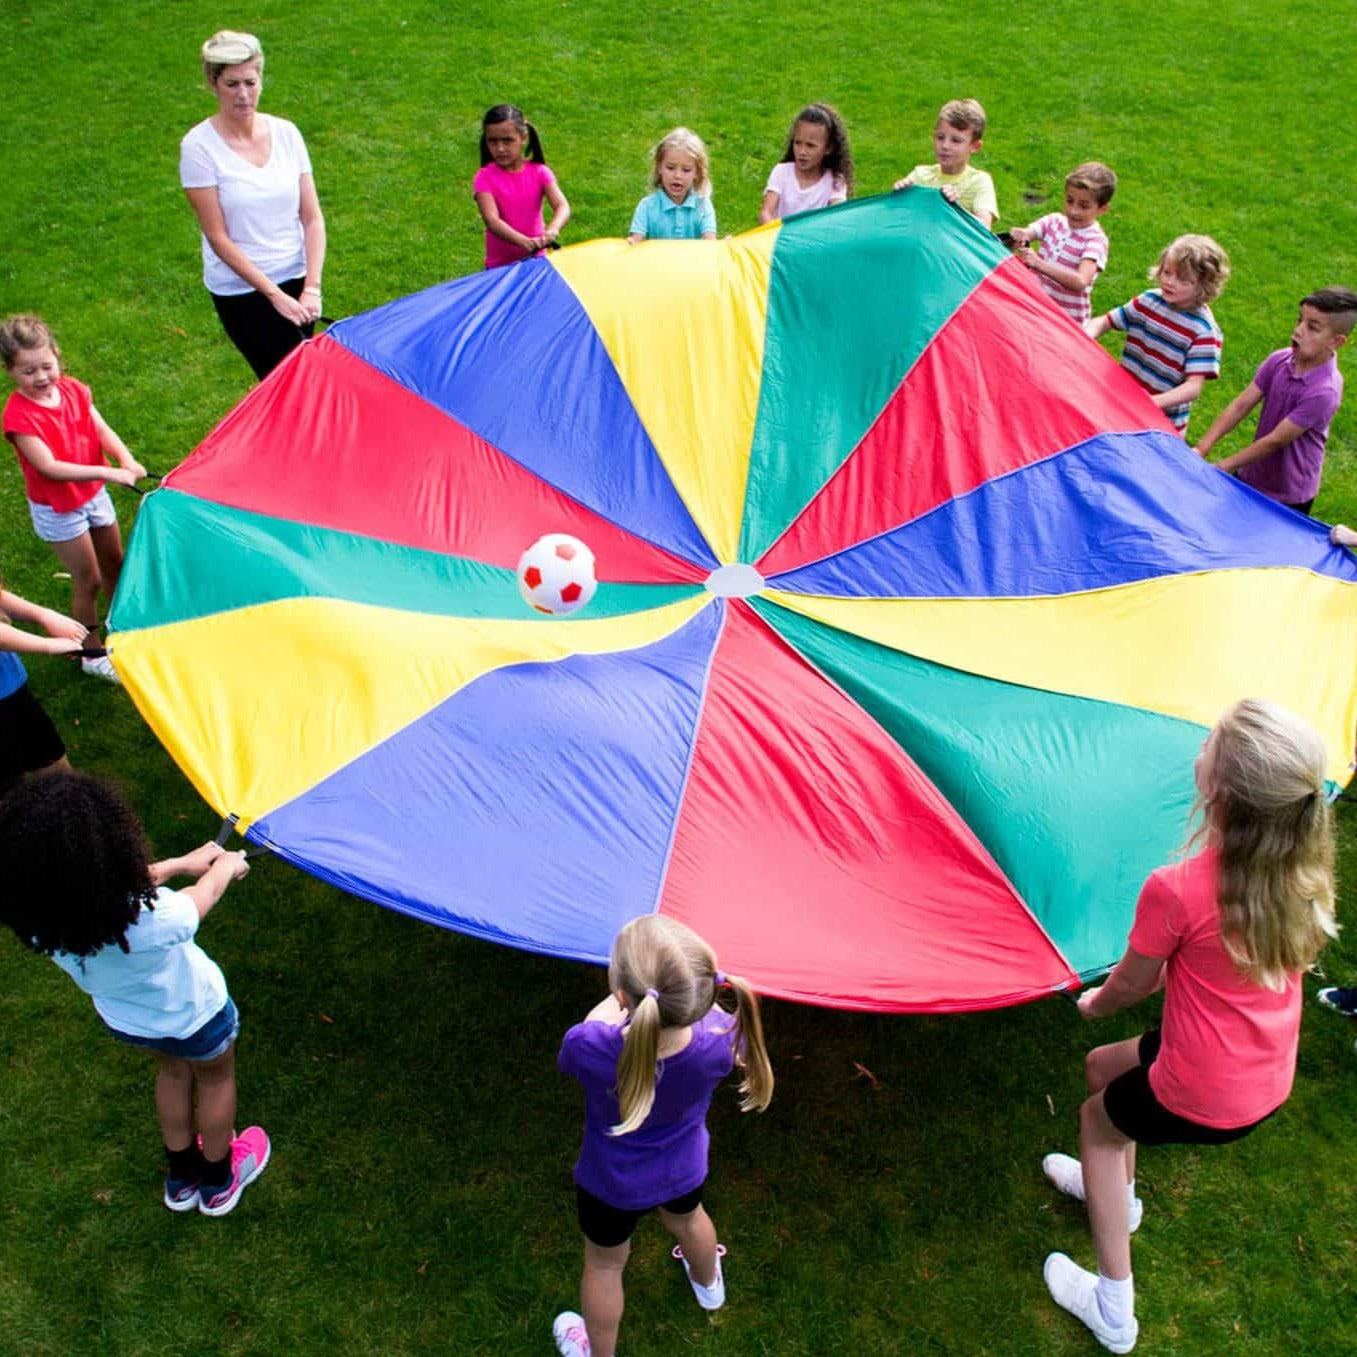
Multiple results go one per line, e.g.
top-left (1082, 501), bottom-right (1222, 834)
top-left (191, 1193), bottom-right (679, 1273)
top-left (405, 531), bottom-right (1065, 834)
top-left (0, 0), bottom-right (1357, 1357)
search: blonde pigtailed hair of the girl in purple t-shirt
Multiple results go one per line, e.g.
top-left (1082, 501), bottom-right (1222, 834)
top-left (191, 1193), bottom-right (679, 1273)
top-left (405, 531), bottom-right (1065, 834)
top-left (608, 915), bottom-right (772, 1136)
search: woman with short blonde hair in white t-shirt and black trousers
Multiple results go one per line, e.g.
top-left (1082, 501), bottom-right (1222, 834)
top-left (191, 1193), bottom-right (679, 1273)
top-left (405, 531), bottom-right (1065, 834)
top-left (179, 31), bottom-right (326, 377)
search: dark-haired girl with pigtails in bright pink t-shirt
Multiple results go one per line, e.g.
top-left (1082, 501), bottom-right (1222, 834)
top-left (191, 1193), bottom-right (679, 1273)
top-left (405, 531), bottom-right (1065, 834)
top-left (471, 103), bottom-right (570, 269)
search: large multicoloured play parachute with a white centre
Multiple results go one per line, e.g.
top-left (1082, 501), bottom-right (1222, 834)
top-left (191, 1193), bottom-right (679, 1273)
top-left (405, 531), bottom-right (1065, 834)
top-left (111, 190), bottom-right (1357, 1010)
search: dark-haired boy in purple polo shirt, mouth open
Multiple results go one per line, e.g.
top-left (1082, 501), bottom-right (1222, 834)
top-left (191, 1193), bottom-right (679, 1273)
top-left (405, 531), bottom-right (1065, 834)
top-left (1197, 288), bottom-right (1357, 513)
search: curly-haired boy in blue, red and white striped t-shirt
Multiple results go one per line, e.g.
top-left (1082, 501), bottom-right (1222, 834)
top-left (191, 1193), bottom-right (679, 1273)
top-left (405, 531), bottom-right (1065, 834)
top-left (1084, 236), bottom-right (1229, 433)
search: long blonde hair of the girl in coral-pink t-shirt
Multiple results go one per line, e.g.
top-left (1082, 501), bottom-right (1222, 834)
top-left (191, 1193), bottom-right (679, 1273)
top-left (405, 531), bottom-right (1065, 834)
top-left (1190, 699), bottom-right (1338, 991)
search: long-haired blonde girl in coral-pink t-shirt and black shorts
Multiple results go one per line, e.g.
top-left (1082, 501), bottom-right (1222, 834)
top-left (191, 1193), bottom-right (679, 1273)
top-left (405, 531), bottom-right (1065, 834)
top-left (1042, 700), bottom-right (1337, 1353)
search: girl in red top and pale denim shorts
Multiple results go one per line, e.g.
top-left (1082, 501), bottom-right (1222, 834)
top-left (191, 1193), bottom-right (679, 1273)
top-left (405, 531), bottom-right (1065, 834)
top-left (0, 316), bottom-right (147, 683)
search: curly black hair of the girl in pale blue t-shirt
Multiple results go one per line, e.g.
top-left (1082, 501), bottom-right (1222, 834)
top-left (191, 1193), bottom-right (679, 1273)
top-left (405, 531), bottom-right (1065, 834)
top-left (0, 772), bottom-right (155, 957)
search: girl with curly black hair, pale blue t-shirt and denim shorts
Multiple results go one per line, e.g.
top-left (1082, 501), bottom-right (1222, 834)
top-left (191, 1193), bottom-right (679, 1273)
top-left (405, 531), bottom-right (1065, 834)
top-left (0, 772), bottom-right (270, 1216)
